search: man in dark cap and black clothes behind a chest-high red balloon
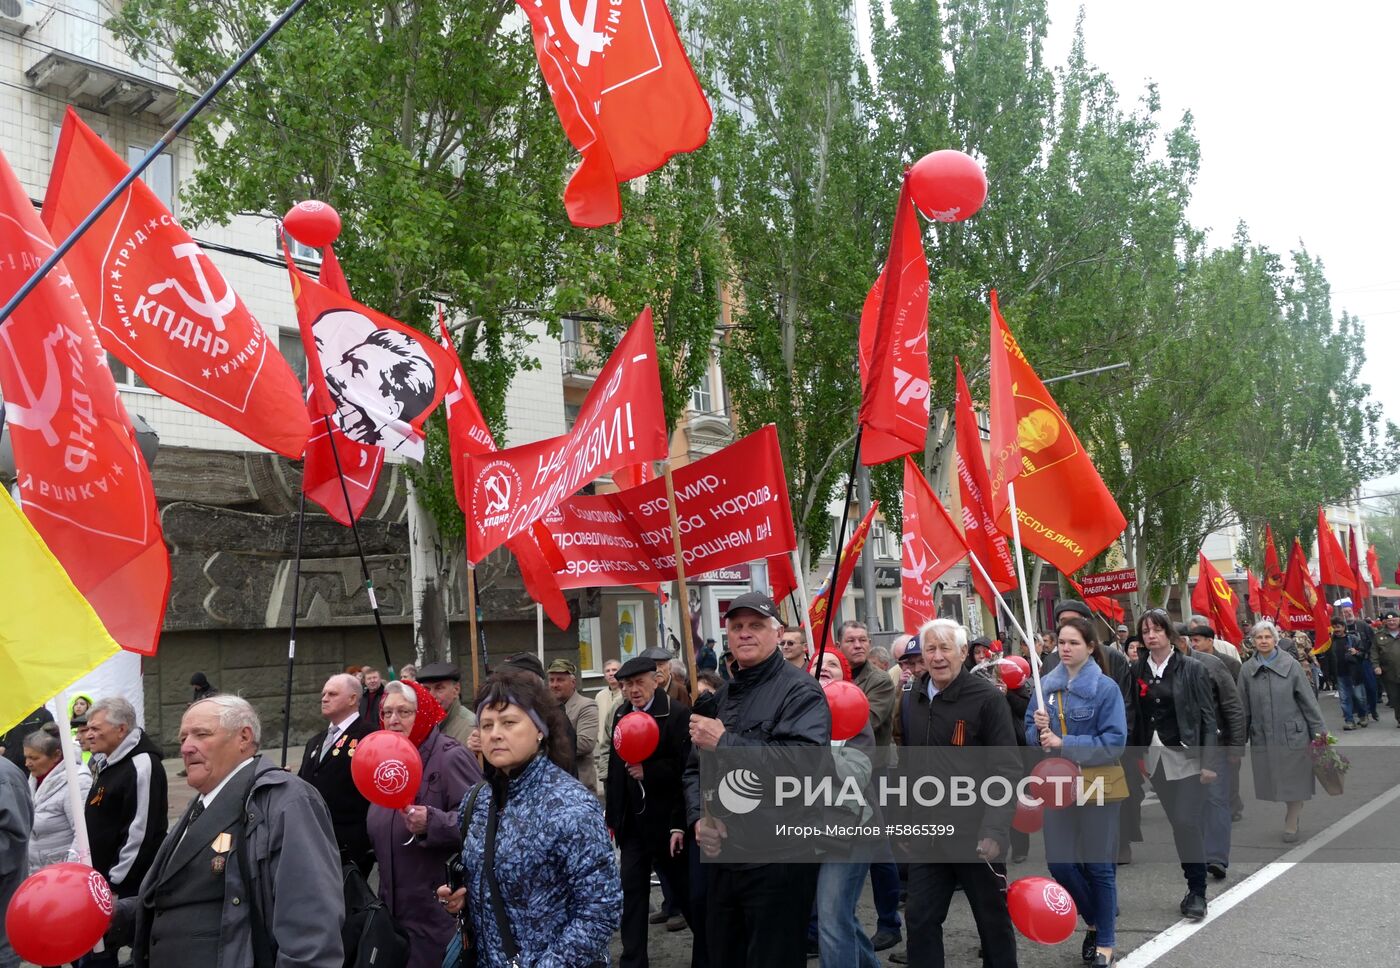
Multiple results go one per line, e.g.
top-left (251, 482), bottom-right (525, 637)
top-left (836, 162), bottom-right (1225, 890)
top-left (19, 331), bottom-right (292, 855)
top-left (606, 656), bottom-right (696, 968)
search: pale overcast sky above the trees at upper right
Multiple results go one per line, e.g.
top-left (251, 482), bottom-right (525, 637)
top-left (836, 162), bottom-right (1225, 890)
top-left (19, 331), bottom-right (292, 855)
top-left (1047, 0), bottom-right (1400, 493)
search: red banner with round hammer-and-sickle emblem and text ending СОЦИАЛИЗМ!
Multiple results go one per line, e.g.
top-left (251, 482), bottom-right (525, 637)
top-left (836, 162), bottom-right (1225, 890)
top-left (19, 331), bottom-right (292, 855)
top-left (466, 308), bottom-right (669, 562)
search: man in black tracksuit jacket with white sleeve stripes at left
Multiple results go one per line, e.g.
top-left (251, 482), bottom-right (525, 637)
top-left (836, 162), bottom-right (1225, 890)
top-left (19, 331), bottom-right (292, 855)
top-left (83, 696), bottom-right (169, 965)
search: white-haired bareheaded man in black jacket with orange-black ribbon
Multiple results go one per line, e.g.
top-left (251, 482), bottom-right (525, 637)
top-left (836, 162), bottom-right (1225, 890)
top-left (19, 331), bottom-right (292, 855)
top-left (902, 619), bottom-right (1022, 968)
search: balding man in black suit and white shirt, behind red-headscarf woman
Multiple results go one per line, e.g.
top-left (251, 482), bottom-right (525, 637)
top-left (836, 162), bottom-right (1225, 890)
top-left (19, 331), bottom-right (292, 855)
top-left (297, 672), bottom-right (379, 877)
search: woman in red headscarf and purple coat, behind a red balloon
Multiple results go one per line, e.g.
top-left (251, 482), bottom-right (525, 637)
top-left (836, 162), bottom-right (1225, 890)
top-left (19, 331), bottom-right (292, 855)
top-left (367, 682), bottom-right (482, 968)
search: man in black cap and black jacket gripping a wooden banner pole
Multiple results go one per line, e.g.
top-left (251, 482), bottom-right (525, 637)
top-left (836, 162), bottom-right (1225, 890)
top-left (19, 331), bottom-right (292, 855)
top-left (685, 591), bottom-right (832, 968)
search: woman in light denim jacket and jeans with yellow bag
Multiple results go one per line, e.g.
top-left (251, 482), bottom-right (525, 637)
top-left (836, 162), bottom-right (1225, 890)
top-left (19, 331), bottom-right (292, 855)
top-left (1026, 616), bottom-right (1128, 965)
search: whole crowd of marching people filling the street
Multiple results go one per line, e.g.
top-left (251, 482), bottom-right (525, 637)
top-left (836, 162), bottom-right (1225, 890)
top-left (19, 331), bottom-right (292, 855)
top-left (0, 593), bottom-right (1377, 968)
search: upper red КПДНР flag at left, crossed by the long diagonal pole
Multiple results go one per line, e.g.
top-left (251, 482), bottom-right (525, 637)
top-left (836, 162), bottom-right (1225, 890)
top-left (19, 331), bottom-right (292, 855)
top-left (43, 108), bottom-right (311, 459)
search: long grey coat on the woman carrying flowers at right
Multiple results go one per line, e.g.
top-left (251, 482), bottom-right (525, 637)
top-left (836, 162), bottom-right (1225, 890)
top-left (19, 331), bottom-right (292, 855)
top-left (1239, 654), bottom-right (1327, 803)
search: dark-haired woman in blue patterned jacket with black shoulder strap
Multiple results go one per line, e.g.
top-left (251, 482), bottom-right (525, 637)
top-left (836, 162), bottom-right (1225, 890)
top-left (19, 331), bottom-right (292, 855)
top-left (438, 668), bottom-right (622, 968)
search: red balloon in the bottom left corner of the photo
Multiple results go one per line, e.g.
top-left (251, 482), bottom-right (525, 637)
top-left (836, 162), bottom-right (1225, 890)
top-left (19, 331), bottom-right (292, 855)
top-left (6, 863), bottom-right (113, 965)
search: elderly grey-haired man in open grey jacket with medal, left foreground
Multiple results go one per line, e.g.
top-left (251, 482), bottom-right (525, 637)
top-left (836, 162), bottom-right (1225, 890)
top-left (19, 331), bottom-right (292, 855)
top-left (108, 695), bottom-right (344, 968)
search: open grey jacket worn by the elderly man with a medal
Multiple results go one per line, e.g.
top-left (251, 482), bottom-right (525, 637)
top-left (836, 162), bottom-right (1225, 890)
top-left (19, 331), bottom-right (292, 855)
top-left (108, 758), bottom-right (346, 968)
